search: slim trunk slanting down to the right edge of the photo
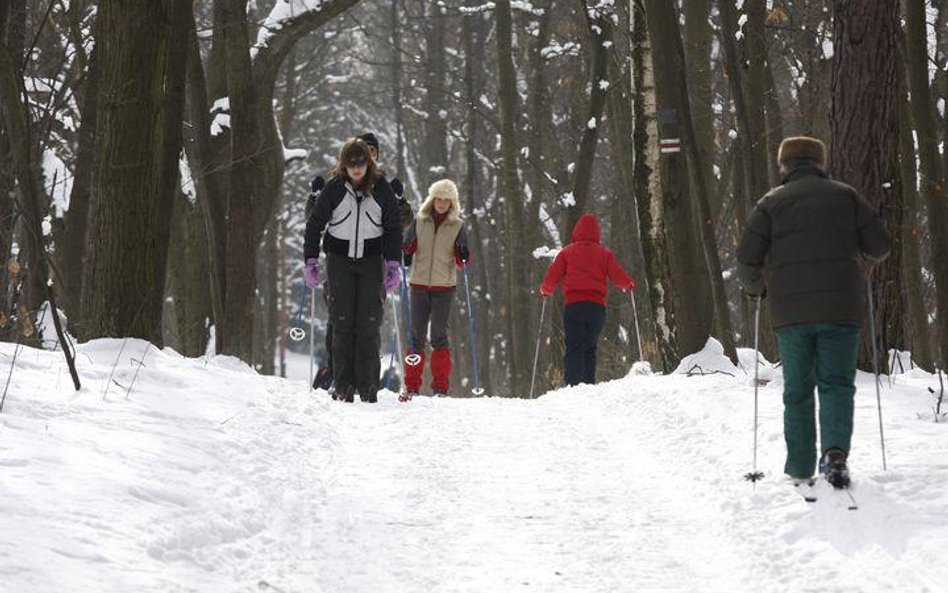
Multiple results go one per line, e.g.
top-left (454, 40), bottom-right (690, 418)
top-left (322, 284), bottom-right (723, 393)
top-left (905, 0), bottom-right (948, 367)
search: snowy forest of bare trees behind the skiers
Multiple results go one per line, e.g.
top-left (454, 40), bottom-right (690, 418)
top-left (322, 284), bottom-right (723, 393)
top-left (0, 0), bottom-right (948, 395)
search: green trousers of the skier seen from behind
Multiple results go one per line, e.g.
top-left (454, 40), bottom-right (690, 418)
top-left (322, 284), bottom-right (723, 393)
top-left (777, 323), bottom-right (859, 478)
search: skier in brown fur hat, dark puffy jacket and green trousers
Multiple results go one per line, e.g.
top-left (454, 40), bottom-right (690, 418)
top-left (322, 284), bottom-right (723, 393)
top-left (737, 136), bottom-right (891, 488)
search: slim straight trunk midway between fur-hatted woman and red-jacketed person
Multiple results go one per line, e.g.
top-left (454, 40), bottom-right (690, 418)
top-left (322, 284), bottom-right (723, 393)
top-left (495, 0), bottom-right (530, 397)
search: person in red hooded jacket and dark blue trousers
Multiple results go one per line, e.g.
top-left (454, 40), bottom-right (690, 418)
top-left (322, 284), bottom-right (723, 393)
top-left (540, 214), bottom-right (635, 385)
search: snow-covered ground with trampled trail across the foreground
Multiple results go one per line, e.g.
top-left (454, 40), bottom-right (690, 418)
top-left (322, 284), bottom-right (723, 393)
top-left (0, 340), bottom-right (948, 593)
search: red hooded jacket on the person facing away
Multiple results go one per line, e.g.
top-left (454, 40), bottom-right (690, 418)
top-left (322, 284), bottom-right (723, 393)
top-left (540, 214), bottom-right (635, 305)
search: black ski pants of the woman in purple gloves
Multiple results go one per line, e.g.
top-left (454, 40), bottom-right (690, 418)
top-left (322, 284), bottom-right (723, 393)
top-left (326, 253), bottom-right (385, 402)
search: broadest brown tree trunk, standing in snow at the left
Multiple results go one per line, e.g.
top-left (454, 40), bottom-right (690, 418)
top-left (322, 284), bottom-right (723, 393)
top-left (82, 0), bottom-right (191, 345)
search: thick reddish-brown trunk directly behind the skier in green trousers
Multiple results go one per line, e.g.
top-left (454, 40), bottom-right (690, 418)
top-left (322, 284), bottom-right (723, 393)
top-left (830, 0), bottom-right (914, 368)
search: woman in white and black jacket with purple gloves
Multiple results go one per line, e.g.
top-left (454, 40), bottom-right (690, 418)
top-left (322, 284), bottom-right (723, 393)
top-left (303, 138), bottom-right (401, 402)
